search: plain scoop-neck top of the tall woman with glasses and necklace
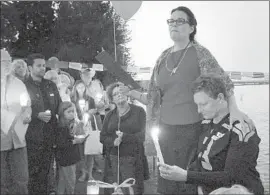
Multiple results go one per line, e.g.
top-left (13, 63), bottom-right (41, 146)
top-left (156, 47), bottom-right (201, 125)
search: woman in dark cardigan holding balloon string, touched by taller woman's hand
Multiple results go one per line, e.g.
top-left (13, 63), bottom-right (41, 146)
top-left (100, 83), bottom-right (149, 195)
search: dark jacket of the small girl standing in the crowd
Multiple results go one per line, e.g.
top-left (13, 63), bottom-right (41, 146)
top-left (56, 127), bottom-right (81, 167)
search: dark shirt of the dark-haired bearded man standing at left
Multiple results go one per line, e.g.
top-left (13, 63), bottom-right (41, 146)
top-left (25, 77), bottom-right (62, 147)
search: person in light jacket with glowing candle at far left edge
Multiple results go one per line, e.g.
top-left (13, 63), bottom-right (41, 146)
top-left (1, 50), bottom-right (31, 194)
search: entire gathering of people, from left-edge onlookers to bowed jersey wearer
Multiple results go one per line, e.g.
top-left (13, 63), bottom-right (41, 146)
top-left (1, 7), bottom-right (264, 195)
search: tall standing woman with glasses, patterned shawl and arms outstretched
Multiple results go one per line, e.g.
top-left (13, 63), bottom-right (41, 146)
top-left (120, 6), bottom-right (253, 194)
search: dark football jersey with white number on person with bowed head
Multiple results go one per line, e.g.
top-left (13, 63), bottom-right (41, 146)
top-left (187, 114), bottom-right (264, 194)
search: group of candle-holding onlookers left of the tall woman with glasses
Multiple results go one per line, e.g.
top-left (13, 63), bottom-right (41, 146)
top-left (1, 50), bottom-right (148, 194)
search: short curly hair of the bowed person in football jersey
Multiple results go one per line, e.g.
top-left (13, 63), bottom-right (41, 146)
top-left (192, 74), bottom-right (228, 100)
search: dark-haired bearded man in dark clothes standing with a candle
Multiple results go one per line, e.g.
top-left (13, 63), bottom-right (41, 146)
top-left (25, 54), bottom-right (61, 194)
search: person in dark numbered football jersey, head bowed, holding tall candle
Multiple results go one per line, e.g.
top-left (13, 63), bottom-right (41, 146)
top-left (160, 75), bottom-right (264, 195)
